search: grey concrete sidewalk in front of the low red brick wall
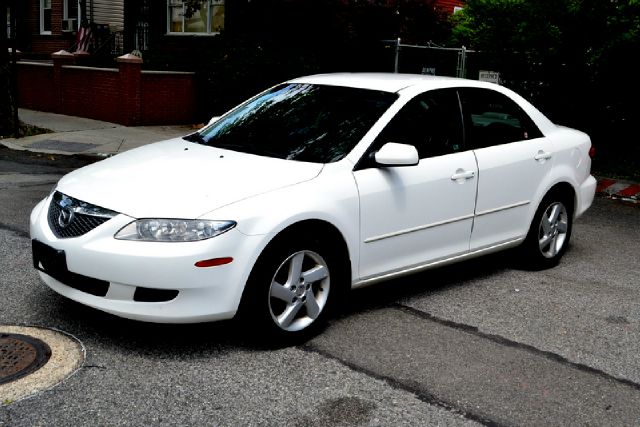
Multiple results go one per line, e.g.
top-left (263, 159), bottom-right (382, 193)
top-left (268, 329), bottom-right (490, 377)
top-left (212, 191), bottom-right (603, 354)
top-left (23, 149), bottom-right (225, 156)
top-left (0, 108), bottom-right (195, 157)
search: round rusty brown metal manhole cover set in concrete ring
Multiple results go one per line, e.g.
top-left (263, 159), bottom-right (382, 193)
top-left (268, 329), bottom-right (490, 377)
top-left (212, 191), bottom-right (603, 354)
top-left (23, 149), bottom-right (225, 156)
top-left (0, 333), bottom-right (51, 384)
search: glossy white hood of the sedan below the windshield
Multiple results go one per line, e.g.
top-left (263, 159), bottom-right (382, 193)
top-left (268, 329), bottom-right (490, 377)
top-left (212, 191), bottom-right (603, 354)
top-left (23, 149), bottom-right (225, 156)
top-left (57, 138), bottom-right (323, 219)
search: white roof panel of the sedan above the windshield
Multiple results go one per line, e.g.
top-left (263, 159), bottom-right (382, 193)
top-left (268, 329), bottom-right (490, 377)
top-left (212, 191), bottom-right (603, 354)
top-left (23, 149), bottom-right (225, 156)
top-left (290, 73), bottom-right (484, 93)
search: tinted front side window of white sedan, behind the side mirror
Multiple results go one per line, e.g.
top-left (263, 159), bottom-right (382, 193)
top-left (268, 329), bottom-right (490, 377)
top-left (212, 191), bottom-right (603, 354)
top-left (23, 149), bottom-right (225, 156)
top-left (376, 89), bottom-right (463, 159)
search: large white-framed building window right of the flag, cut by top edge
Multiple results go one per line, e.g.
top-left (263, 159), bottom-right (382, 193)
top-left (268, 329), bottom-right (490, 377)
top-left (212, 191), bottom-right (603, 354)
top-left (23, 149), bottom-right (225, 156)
top-left (167, 0), bottom-right (224, 34)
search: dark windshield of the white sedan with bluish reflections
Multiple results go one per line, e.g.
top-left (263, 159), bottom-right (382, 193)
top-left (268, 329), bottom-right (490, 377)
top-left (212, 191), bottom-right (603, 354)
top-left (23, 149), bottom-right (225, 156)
top-left (185, 83), bottom-right (397, 163)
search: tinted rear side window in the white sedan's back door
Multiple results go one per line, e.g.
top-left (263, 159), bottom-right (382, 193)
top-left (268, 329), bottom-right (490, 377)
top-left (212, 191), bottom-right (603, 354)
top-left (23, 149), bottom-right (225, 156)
top-left (461, 88), bottom-right (542, 148)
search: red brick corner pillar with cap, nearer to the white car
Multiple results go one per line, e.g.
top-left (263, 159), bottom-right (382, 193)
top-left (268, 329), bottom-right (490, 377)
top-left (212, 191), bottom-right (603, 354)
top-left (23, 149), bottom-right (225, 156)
top-left (116, 54), bottom-right (142, 126)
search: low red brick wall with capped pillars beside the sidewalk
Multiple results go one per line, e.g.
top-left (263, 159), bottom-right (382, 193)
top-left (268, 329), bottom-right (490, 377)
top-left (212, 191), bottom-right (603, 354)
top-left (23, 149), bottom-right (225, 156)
top-left (18, 55), bottom-right (196, 126)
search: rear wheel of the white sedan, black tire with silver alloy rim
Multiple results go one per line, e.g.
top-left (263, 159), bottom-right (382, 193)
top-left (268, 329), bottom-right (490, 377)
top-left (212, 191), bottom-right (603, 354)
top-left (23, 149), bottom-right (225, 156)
top-left (521, 191), bottom-right (573, 270)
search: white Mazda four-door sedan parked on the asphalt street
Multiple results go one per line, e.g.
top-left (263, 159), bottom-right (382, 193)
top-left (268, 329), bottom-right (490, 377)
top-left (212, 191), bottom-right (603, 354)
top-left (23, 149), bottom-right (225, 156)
top-left (30, 74), bottom-right (596, 339)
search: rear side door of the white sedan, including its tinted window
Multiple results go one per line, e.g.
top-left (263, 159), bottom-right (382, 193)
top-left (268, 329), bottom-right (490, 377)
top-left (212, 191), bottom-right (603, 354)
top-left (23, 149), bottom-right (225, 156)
top-left (460, 88), bottom-right (553, 251)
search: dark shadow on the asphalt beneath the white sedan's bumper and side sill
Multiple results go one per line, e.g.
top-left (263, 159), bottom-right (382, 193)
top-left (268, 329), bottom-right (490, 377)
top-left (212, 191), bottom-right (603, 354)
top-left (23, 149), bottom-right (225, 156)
top-left (36, 252), bottom-right (514, 356)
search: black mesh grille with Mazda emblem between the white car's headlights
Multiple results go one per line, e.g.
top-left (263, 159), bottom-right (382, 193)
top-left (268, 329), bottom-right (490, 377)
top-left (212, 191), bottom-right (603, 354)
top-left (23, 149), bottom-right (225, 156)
top-left (48, 191), bottom-right (117, 239)
